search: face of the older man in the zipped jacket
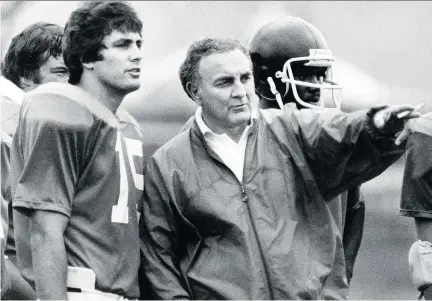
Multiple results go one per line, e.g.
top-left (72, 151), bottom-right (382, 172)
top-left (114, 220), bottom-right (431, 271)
top-left (196, 50), bottom-right (255, 133)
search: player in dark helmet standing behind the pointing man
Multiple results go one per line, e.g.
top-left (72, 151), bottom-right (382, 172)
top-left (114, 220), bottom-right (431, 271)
top-left (248, 17), bottom-right (365, 294)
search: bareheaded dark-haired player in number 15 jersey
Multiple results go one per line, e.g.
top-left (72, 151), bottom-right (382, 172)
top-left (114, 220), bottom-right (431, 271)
top-left (11, 1), bottom-right (143, 300)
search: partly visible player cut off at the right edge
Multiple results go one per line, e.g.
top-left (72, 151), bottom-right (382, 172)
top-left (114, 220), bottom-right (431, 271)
top-left (400, 120), bottom-right (432, 300)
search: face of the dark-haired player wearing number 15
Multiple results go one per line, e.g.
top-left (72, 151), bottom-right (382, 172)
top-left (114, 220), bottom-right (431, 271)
top-left (94, 30), bottom-right (142, 93)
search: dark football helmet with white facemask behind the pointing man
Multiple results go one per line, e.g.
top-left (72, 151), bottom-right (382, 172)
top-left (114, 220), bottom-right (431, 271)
top-left (248, 17), bottom-right (342, 109)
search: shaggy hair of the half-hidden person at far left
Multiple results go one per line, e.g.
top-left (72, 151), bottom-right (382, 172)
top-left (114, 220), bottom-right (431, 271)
top-left (1, 22), bottom-right (63, 88)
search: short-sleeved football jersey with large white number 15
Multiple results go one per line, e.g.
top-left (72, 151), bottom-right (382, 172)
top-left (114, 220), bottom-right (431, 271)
top-left (11, 83), bottom-right (143, 298)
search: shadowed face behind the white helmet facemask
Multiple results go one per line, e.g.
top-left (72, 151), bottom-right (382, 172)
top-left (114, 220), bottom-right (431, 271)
top-left (293, 67), bottom-right (327, 105)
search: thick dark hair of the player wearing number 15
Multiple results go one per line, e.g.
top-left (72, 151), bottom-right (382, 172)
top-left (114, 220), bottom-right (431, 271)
top-left (63, 1), bottom-right (142, 84)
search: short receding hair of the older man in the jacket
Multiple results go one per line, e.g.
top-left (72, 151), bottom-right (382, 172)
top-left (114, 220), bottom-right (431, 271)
top-left (179, 37), bottom-right (249, 99)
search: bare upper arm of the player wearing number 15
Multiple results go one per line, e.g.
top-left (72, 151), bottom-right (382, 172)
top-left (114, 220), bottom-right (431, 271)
top-left (30, 210), bottom-right (69, 300)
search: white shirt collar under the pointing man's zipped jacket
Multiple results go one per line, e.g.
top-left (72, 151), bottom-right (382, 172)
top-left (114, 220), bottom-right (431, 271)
top-left (195, 106), bottom-right (258, 182)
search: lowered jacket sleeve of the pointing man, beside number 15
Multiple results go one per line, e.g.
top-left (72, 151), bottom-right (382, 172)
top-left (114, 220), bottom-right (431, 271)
top-left (140, 157), bottom-right (191, 300)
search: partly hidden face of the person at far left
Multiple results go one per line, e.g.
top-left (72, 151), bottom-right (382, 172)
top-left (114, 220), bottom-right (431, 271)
top-left (23, 55), bottom-right (69, 92)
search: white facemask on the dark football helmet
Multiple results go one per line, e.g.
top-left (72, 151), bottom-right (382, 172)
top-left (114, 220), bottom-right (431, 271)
top-left (267, 49), bottom-right (342, 110)
